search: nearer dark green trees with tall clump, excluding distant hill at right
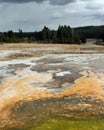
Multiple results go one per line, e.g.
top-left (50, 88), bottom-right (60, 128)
top-left (0, 25), bottom-right (80, 44)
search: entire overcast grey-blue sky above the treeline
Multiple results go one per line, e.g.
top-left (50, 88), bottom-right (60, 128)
top-left (0, 0), bottom-right (104, 32)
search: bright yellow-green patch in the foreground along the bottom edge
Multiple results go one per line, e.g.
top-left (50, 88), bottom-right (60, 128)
top-left (28, 119), bottom-right (104, 130)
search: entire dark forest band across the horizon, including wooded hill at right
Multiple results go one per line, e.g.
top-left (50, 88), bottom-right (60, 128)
top-left (0, 25), bottom-right (104, 44)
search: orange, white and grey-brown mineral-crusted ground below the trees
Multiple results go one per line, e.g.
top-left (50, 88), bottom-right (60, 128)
top-left (0, 44), bottom-right (104, 129)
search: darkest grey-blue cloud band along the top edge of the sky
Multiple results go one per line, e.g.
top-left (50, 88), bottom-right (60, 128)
top-left (0, 0), bottom-right (77, 5)
